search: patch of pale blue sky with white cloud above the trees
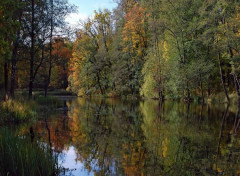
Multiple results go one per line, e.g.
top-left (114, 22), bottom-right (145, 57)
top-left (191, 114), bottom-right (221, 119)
top-left (66, 0), bottom-right (117, 26)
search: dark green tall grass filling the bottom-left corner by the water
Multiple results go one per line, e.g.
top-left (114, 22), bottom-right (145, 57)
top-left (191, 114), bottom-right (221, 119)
top-left (0, 128), bottom-right (57, 176)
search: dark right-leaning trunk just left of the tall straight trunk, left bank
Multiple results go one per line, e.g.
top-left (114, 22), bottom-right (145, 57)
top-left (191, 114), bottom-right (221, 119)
top-left (10, 30), bottom-right (20, 98)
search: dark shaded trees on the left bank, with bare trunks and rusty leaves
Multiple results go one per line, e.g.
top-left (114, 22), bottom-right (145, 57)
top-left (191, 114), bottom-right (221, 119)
top-left (0, 0), bottom-right (75, 98)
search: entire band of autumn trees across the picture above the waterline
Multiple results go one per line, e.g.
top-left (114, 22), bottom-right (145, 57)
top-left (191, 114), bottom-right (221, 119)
top-left (0, 0), bottom-right (240, 102)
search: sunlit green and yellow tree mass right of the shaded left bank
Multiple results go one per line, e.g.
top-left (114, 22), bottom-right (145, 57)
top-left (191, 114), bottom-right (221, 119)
top-left (68, 0), bottom-right (239, 99)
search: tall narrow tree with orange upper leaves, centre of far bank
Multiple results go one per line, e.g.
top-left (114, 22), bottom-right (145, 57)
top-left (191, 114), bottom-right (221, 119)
top-left (122, 3), bottom-right (148, 94)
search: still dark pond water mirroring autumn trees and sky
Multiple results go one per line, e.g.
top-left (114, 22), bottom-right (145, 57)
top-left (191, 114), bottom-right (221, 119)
top-left (5, 98), bottom-right (240, 176)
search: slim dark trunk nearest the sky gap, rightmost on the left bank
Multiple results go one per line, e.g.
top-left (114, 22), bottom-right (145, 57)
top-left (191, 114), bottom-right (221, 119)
top-left (45, 0), bottom-right (53, 97)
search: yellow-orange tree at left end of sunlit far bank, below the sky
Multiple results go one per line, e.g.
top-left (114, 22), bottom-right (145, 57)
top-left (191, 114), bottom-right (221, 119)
top-left (70, 10), bottom-right (112, 95)
